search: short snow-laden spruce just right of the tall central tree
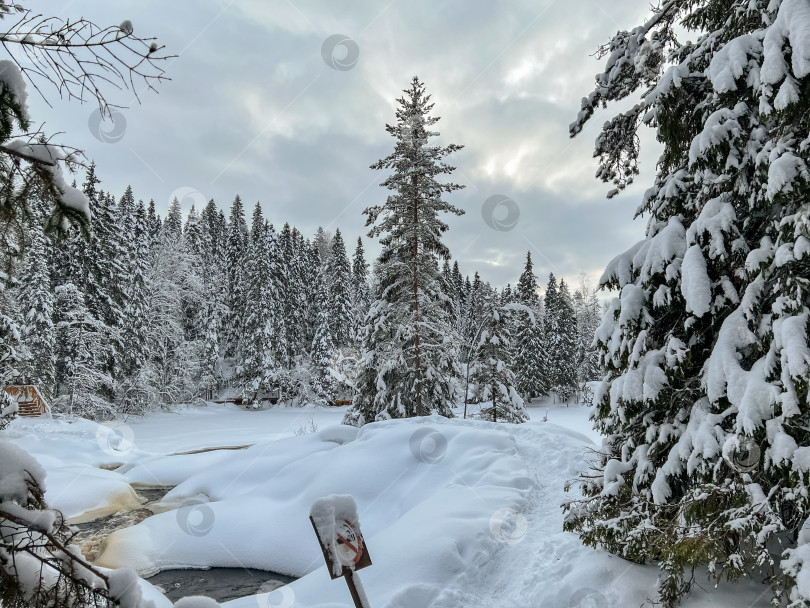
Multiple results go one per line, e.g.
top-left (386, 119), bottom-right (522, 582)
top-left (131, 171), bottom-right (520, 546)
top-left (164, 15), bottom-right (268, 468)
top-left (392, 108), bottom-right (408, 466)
top-left (469, 298), bottom-right (529, 423)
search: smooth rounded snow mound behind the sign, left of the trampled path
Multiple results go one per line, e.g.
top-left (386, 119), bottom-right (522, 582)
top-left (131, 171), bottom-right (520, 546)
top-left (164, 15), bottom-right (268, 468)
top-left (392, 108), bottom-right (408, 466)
top-left (97, 417), bottom-right (536, 605)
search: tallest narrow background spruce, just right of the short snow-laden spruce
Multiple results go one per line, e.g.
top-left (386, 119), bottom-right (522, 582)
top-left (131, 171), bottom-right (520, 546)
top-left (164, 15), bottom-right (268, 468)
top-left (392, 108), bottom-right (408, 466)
top-left (513, 252), bottom-right (547, 401)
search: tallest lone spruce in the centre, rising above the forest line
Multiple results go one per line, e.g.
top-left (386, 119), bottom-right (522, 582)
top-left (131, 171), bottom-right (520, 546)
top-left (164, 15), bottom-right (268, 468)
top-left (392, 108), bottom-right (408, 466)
top-left (344, 77), bottom-right (464, 426)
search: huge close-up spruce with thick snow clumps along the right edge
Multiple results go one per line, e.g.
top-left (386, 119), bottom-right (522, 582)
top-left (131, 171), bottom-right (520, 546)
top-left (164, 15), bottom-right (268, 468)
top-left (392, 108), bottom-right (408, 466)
top-left (565, 0), bottom-right (810, 606)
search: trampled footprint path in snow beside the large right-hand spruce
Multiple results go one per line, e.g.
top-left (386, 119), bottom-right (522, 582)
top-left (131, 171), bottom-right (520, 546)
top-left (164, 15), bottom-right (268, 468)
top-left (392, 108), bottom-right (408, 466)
top-left (442, 423), bottom-right (770, 608)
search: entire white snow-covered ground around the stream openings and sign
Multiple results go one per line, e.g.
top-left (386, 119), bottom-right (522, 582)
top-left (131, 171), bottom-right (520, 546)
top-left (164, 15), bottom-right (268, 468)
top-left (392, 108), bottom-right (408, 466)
top-left (3, 402), bottom-right (768, 608)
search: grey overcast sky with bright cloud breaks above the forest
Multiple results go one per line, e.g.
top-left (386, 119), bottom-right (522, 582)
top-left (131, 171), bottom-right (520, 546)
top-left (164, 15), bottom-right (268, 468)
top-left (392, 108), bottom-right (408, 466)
top-left (22, 0), bottom-right (658, 286)
